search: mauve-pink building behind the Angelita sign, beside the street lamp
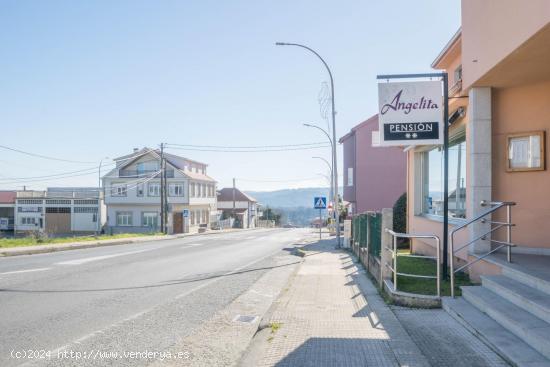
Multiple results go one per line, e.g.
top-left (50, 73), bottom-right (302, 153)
top-left (339, 114), bottom-right (407, 214)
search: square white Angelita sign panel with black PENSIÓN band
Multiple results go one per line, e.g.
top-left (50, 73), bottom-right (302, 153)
top-left (378, 81), bottom-right (443, 146)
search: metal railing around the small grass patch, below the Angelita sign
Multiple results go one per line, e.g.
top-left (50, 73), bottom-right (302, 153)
top-left (384, 228), bottom-right (441, 297)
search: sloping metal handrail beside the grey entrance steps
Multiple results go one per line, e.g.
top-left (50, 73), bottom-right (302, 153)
top-left (449, 200), bottom-right (516, 297)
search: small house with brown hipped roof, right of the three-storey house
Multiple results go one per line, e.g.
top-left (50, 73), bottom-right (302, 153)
top-left (218, 187), bottom-right (259, 228)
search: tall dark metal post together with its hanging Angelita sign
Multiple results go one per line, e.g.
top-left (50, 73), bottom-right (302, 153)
top-left (377, 73), bottom-right (452, 278)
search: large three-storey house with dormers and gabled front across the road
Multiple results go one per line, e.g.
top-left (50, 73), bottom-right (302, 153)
top-left (103, 148), bottom-right (216, 233)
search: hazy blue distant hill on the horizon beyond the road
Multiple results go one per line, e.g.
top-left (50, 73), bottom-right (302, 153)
top-left (246, 187), bottom-right (330, 208)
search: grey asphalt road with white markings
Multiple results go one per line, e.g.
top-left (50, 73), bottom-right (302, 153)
top-left (0, 229), bottom-right (311, 366)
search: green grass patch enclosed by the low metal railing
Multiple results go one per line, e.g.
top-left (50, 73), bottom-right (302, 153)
top-left (397, 250), bottom-right (472, 296)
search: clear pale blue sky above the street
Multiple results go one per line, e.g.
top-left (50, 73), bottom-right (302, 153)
top-left (0, 0), bottom-right (460, 191)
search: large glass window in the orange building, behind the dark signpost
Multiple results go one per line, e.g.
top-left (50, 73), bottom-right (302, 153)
top-left (420, 135), bottom-right (466, 218)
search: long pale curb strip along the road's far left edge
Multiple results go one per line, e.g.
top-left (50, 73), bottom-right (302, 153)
top-left (0, 228), bottom-right (266, 257)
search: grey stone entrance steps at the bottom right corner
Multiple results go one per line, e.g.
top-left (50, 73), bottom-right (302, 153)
top-left (442, 257), bottom-right (550, 367)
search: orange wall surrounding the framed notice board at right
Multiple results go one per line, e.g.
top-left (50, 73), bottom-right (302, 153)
top-left (492, 79), bottom-right (550, 248)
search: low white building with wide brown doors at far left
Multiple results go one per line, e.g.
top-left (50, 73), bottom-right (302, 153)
top-left (13, 187), bottom-right (105, 235)
